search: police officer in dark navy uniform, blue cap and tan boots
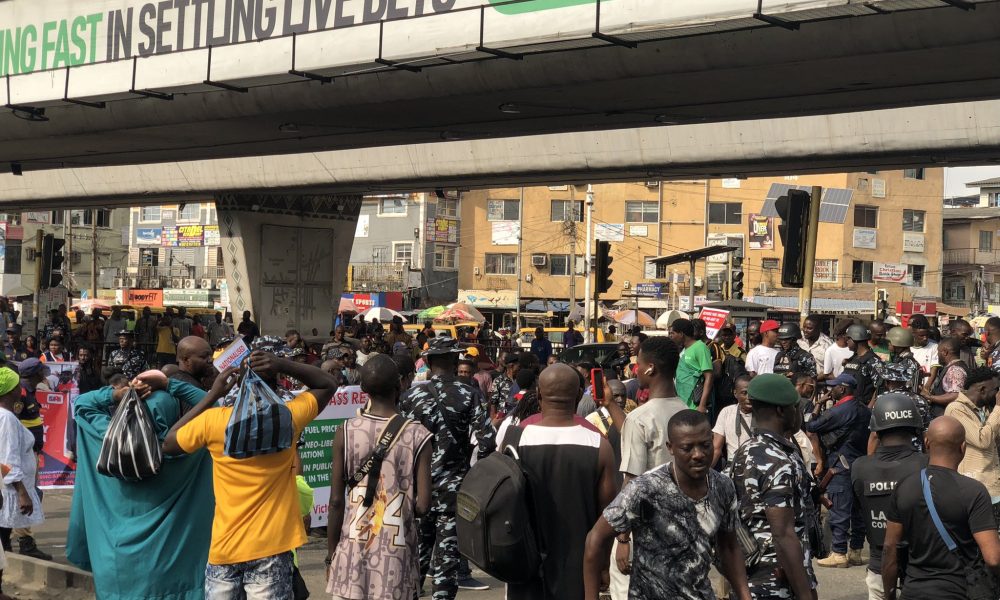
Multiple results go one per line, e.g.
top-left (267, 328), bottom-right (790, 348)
top-left (805, 370), bottom-right (871, 568)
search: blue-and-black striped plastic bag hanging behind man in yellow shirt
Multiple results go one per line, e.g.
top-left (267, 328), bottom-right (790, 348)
top-left (223, 368), bottom-right (293, 458)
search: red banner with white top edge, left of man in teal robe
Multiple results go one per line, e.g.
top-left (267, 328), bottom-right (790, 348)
top-left (35, 362), bottom-right (80, 489)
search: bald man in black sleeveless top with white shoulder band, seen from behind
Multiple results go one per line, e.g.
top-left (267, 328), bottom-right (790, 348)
top-left (504, 363), bottom-right (617, 600)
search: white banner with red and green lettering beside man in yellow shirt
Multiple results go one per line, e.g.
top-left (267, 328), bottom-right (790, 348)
top-left (299, 385), bottom-right (368, 527)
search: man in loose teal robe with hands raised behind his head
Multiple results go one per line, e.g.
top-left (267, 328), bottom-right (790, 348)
top-left (66, 378), bottom-right (215, 600)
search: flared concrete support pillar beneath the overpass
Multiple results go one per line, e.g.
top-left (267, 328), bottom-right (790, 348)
top-left (215, 193), bottom-right (361, 336)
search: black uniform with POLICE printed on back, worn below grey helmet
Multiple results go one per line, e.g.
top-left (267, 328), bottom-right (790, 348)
top-left (851, 446), bottom-right (927, 584)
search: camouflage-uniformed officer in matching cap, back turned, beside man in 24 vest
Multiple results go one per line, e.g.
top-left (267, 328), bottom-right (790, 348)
top-left (399, 336), bottom-right (496, 600)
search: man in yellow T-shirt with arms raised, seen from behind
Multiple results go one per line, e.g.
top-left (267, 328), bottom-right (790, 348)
top-left (163, 351), bottom-right (336, 600)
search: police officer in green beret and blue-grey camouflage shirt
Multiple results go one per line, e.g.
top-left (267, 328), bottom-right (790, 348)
top-left (732, 373), bottom-right (816, 600)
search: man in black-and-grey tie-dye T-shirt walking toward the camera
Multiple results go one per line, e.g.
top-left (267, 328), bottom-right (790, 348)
top-left (584, 410), bottom-right (751, 600)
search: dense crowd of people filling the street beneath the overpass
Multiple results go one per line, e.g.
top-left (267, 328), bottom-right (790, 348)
top-left (0, 307), bottom-right (1000, 600)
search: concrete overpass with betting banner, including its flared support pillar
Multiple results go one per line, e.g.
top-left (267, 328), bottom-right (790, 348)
top-left (0, 0), bottom-right (1000, 329)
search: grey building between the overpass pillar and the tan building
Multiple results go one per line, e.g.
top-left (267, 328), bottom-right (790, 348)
top-left (344, 192), bottom-right (462, 309)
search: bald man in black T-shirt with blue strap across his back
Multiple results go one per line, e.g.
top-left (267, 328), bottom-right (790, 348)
top-left (882, 416), bottom-right (1000, 600)
